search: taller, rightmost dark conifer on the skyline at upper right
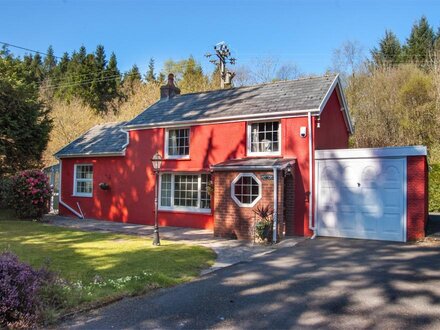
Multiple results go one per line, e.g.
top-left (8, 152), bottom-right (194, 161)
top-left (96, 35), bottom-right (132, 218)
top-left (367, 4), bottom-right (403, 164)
top-left (404, 16), bottom-right (435, 66)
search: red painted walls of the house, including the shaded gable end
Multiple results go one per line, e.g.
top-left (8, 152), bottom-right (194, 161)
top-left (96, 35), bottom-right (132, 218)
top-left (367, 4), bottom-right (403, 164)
top-left (60, 86), bottom-right (348, 235)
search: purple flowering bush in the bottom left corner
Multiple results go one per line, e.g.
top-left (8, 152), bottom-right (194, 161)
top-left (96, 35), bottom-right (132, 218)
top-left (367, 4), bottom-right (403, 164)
top-left (0, 252), bottom-right (48, 328)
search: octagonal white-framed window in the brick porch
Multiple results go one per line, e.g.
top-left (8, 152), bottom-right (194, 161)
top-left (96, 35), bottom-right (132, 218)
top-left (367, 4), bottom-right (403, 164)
top-left (231, 173), bottom-right (261, 207)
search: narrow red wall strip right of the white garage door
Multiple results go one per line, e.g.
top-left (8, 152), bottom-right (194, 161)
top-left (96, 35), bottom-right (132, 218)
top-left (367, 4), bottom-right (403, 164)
top-left (407, 156), bottom-right (428, 241)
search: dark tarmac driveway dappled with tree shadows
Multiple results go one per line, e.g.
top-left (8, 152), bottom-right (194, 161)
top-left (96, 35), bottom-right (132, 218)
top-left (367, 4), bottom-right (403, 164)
top-left (61, 238), bottom-right (440, 329)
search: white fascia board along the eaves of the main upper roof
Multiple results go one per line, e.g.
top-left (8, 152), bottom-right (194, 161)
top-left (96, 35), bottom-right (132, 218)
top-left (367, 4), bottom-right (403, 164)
top-left (124, 109), bottom-right (319, 131)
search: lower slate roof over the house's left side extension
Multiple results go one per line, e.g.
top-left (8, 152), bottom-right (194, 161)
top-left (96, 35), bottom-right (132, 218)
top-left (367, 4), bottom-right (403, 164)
top-left (55, 122), bottom-right (128, 158)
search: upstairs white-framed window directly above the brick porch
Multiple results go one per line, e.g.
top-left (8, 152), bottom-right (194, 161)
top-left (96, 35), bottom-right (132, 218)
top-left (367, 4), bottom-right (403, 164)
top-left (247, 121), bottom-right (281, 156)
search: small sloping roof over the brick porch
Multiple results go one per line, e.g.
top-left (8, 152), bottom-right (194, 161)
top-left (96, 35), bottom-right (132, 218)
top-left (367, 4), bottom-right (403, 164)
top-left (211, 157), bottom-right (296, 171)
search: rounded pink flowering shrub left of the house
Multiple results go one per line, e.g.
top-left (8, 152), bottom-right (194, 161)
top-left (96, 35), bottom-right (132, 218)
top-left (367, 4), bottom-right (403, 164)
top-left (11, 170), bottom-right (52, 219)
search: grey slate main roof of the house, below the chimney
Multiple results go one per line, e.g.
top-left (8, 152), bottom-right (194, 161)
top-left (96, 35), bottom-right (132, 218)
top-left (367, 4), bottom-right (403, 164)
top-left (127, 75), bottom-right (337, 128)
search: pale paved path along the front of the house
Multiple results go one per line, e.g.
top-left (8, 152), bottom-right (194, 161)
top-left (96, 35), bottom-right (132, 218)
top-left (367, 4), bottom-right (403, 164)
top-left (44, 215), bottom-right (305, 274)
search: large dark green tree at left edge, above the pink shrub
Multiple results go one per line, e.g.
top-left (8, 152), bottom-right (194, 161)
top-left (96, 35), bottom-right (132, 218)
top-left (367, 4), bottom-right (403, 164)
top-left (0, 52), bottom-right (52, 176)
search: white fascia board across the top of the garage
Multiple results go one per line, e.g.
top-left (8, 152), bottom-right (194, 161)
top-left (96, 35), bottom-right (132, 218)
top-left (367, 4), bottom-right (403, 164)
top-left (315, 146), bottom-right (428, 160)
